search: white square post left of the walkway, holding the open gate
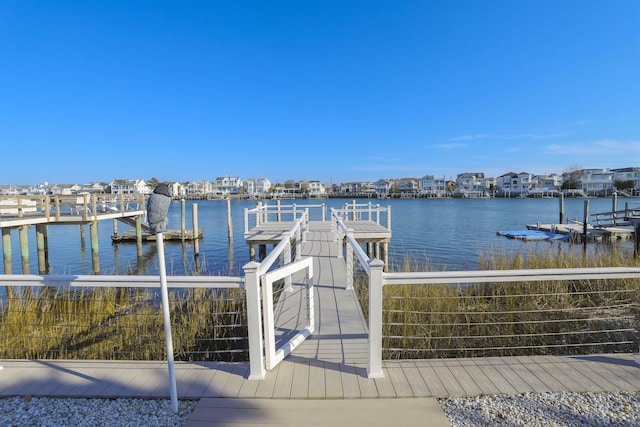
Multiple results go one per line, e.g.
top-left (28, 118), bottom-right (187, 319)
top-left (242, 262), bottom-right (266, 380)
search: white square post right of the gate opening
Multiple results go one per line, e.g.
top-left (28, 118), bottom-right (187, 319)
top-left (367, 259), bottom-right (384, 378)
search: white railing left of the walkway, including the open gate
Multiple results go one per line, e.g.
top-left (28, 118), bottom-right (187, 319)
top-left (0, 211), bottom-right (314, 379)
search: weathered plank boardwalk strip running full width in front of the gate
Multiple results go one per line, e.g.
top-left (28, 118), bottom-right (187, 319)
top-left (0, 354), bottom-right (640, 399)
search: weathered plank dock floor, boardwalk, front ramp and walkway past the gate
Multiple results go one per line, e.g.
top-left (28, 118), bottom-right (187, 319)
top-left (0, 223), bottom-right (640, 427)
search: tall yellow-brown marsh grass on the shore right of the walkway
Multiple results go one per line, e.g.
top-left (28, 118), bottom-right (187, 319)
top-left (357, 250), bottom-right (640, 359)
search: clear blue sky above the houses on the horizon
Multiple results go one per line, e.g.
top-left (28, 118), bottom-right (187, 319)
top-left (0, 0), bottom-right (640, 184)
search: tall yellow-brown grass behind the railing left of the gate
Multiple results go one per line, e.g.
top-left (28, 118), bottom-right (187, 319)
top-left (0, 287), bottom-right (248, 361)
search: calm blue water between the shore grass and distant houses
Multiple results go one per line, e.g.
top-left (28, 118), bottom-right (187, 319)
top-left (0, 198), bottom-right (638, 275)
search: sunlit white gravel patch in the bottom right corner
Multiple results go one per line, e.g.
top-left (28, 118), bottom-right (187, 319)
top-left (439, 392), bottom-right (640, 427)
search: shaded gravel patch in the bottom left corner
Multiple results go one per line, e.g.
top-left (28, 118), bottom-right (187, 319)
top-left (0, 396), bottom-right (197, 427)
